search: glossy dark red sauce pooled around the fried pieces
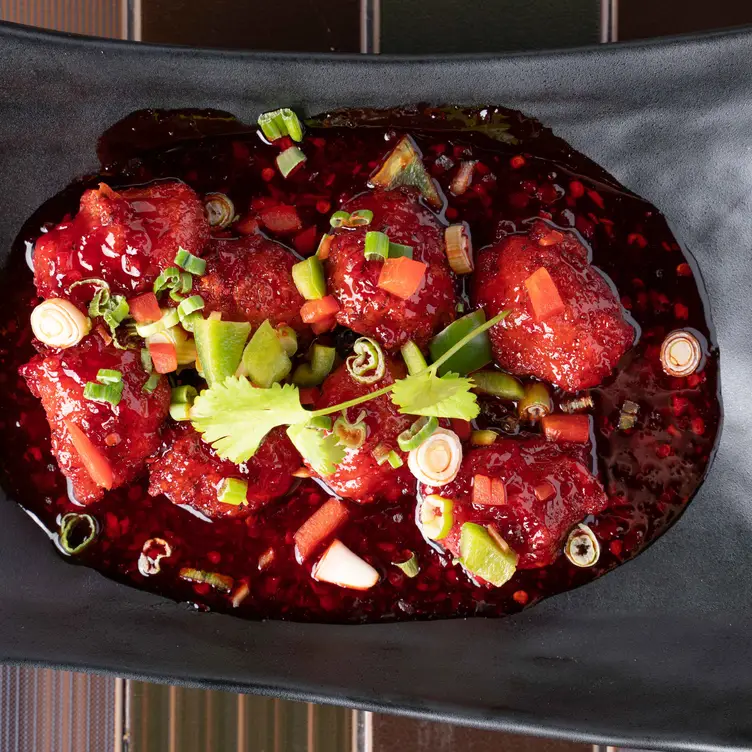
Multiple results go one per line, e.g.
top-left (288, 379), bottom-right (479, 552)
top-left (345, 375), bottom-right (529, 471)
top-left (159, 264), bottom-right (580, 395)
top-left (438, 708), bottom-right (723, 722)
top-left (0, 110), bottom-right (721, 622)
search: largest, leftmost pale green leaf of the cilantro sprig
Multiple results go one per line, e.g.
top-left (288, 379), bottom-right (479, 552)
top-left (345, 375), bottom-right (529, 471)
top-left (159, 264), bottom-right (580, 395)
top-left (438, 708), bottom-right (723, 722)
top-left (191, 376), bottom-right (308, 464)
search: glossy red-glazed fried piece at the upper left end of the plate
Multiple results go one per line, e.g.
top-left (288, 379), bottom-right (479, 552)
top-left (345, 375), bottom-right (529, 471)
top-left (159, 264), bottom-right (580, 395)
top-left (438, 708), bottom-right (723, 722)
top-left (34, 181), bottom-right (209, 303)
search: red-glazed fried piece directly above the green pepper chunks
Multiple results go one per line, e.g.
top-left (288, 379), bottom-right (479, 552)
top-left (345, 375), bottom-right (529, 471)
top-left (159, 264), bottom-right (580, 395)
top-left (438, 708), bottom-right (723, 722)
top-left (197, 235), bottom-right (309, 333)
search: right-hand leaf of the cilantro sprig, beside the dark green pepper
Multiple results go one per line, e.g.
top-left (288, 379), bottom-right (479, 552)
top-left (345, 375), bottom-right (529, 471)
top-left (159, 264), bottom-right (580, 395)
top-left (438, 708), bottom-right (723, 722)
top-left (392, 369), bottom-right (480, 420)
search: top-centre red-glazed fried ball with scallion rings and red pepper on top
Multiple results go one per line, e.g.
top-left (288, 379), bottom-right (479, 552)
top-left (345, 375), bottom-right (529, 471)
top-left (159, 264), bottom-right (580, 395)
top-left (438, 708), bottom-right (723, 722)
top-left (326, 190), bottom-right (455, 350)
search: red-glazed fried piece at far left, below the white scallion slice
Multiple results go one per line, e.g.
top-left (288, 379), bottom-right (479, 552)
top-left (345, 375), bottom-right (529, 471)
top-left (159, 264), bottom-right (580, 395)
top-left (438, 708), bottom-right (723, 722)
top-left (21, 335), bottom-right (170, 504)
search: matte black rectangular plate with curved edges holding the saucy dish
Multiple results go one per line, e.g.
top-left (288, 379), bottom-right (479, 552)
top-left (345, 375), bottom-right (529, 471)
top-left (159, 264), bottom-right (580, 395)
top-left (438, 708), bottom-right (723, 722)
top-left (0, 20), bottom-right (752, 749)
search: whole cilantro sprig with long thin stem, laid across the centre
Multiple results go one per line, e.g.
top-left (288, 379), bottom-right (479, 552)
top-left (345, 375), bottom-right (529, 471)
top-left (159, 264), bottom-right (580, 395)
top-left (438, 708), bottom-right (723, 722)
top-left (191, 311), bottom-right (507, 475)
